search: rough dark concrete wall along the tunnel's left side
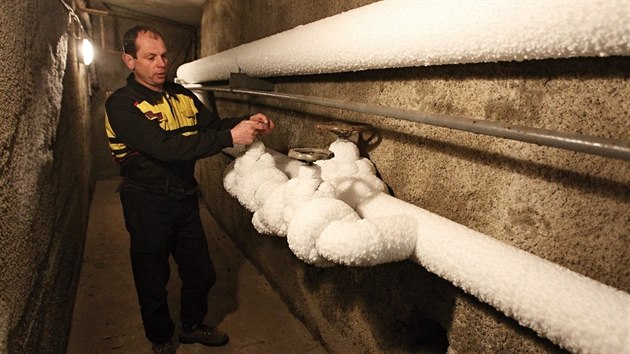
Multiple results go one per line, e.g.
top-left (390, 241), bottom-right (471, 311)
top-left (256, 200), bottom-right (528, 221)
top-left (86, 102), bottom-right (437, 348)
top-left (0, 0), bottom-right (93, 353)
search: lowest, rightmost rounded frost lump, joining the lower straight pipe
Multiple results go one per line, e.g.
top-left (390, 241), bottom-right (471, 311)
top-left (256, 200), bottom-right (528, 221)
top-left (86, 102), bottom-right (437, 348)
top-left (316, 214), bottom-right (416, 266)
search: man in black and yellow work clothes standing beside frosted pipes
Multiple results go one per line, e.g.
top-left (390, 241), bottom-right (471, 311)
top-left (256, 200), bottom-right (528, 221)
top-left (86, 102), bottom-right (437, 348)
top-left (105, 26), bottom-right (274, 353)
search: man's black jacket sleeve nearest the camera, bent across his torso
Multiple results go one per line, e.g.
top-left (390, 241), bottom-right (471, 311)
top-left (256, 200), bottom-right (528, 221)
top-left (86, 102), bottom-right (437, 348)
top-left (105, 95), bottom-right (233, 162)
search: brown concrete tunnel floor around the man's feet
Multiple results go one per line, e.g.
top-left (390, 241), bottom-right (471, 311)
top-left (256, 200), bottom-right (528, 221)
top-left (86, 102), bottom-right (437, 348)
top-left (67, 179), bottom-right (326, 354)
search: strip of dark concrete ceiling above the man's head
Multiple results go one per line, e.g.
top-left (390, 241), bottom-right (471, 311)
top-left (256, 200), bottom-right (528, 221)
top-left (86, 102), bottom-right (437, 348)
top-left (101, 0), bottom-right (206, 26)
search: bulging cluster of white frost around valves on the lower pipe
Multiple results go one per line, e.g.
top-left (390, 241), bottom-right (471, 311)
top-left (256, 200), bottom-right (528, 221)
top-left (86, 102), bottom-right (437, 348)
top-left (224, 139), bottom-right (416, 266)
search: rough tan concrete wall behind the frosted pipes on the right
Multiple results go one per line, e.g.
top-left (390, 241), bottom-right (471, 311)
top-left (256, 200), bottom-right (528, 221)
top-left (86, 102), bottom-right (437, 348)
top-left (198, 0), bottom-right (630, 353)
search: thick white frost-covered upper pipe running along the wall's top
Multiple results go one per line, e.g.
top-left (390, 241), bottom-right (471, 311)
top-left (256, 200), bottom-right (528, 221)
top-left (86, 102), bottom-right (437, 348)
top-left (177, 0), bottom-right (630, 83)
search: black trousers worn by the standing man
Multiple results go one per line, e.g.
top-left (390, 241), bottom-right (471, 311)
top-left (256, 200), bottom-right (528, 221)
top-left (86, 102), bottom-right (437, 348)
top-left (120, 183), bottom-right (216, 344)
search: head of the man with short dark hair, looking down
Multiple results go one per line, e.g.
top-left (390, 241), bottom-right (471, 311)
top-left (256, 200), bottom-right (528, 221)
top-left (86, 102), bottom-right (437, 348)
top-left (123, 32), bottom-right (168, 91)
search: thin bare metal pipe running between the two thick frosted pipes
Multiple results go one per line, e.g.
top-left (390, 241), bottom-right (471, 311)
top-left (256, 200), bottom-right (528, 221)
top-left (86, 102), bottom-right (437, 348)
top-left (187, 85), bottom-right (630, 161)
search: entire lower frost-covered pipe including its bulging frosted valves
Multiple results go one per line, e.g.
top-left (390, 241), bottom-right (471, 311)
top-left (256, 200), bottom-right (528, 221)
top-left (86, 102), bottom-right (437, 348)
top-left (224, 141), bottom-right (630, 353)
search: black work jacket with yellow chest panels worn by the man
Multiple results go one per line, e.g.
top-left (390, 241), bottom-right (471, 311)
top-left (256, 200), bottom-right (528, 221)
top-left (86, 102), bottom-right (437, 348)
top-left (105, 73), bottom-right (247, 190)
